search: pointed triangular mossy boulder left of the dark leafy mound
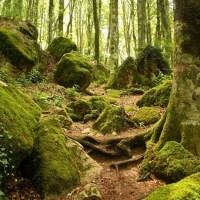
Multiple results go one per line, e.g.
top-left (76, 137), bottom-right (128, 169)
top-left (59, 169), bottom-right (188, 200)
top-left (108, 57), bottom-right (139, 89)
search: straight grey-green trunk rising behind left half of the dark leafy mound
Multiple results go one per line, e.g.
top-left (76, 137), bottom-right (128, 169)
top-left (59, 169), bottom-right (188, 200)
top-left (137, 0), bottom-right (146, 49)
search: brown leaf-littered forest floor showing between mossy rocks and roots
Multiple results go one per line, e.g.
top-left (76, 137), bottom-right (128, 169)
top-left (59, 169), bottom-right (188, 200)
top-left (8, 87), bottom-right (165, 200)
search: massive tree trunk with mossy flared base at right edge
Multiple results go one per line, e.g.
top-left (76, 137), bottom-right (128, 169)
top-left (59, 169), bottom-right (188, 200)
top-left (142, 0), bottom-right (200, 175)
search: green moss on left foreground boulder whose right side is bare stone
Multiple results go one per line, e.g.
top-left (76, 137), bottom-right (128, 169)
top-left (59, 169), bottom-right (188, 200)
top-left (23, 117), bottom-right (80, 197)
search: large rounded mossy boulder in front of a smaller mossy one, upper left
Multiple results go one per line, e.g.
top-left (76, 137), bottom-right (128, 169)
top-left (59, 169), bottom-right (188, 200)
top-left (54, 52), bottom-right (93, 91)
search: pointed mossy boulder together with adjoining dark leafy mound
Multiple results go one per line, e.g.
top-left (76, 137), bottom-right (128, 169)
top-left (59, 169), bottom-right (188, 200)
top-left (107, 46), bottom-right (170, 89)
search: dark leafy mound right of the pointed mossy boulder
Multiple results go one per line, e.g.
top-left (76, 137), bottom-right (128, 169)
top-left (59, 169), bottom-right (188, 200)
top-left (136, 45), bottom-right (170, 79)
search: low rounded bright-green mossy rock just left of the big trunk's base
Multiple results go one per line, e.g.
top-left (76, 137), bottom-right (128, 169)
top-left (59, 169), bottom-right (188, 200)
top-left (132, 107), bottom-right (161, 125)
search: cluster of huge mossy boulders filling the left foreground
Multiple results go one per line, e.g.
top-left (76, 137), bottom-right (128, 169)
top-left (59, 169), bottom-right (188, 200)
top-left (0, 82), bottom-right (101, 197)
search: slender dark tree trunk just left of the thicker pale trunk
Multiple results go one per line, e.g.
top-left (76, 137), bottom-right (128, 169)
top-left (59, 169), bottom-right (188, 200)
top-left (93, 0), bottom-right (99, 65)
